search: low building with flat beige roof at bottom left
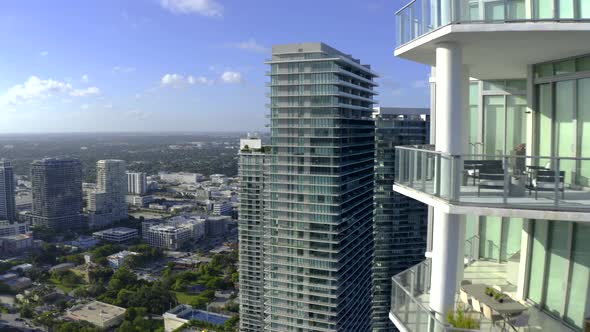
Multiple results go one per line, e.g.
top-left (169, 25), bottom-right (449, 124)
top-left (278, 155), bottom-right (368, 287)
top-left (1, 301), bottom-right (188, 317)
top-left (65, 301), bottom-right (126, 329)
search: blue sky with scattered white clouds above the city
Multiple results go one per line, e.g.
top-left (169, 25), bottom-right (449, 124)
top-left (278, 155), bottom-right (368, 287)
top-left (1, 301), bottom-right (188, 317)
top-left (0, 0), bottom-right (429, 134)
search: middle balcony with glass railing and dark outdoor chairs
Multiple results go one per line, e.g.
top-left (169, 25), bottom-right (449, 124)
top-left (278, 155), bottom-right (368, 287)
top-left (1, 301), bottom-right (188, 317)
top-left (394, 146), bottom-right (590, 221)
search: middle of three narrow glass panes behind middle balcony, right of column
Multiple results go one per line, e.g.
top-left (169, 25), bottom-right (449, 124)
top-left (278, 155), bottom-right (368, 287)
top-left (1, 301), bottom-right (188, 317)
top-left (484, 96), bottom-right (505, 154)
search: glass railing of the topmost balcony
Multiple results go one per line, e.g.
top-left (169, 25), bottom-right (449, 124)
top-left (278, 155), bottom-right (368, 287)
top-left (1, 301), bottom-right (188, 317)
top-left (395, 0), bottom-right (590, 47)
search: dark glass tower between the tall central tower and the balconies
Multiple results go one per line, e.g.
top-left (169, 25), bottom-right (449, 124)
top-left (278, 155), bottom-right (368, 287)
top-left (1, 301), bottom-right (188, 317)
top-left (373, 107), bottom-right (430, 332)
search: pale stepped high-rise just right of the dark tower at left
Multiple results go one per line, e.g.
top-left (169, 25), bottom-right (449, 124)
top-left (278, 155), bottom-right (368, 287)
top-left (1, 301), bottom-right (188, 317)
top-left (88, 159), bottom-right (128, 228)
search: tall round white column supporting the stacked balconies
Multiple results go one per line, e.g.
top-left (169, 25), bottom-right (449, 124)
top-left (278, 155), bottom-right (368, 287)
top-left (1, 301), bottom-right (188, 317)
top-left (430, 43), bottom-right (469, 320)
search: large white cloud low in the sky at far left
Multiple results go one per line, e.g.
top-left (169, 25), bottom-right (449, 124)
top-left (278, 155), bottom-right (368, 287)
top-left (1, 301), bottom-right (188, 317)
top-left (0, 76), bottom-right (100, 105)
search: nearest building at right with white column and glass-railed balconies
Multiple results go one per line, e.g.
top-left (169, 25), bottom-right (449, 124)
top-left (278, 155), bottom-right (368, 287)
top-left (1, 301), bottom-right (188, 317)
top-left (390, 0), bottom-right (590, 331)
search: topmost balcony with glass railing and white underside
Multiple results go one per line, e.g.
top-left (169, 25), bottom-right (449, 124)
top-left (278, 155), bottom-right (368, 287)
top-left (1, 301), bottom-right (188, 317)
top-left (395, 0), bottom-right (590, 80)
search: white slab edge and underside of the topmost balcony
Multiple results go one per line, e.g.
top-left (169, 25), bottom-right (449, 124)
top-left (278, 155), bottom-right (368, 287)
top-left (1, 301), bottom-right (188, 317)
top-left (395, 22), bottom-right (590, 80)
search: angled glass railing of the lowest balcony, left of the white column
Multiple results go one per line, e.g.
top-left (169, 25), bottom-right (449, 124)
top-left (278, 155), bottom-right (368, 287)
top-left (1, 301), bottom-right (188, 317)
top-left (390, 259), bottom-right (479, 332)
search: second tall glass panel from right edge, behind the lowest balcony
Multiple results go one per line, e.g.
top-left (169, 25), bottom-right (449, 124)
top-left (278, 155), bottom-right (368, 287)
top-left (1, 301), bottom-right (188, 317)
top-left (544, 222), bottom-right (569, 316)
